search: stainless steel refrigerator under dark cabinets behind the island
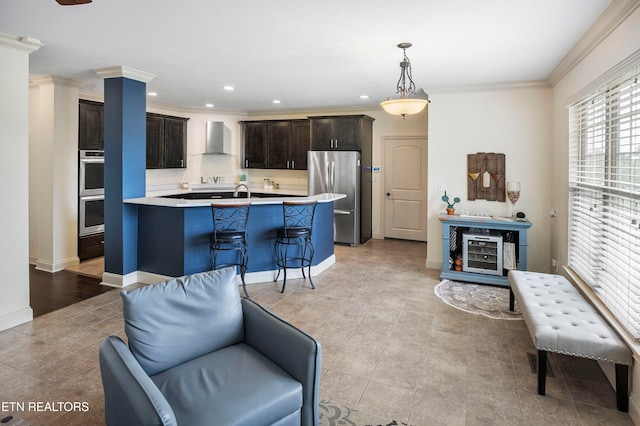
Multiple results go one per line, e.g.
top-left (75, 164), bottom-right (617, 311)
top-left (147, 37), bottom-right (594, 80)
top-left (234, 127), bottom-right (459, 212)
top-left (307, 151), bottom-right (362, 246)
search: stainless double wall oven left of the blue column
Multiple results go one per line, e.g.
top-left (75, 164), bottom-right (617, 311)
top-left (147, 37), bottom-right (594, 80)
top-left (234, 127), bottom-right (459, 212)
top-left (78, 150), bottom-right (104, 237)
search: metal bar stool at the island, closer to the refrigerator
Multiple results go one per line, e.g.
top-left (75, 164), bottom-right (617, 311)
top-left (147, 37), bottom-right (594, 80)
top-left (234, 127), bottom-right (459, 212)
top-left (274, 201), bottom-right (316, 293)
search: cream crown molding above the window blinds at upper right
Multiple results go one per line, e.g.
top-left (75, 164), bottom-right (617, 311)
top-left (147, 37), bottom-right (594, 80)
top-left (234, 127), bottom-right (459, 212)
top-left (547, 0), bottom-right (640, 87)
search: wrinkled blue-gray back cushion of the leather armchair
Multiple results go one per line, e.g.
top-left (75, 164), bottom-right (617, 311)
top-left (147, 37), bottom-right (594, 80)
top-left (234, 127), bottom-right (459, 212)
top-left (121, 268), bottom-right (244, 376)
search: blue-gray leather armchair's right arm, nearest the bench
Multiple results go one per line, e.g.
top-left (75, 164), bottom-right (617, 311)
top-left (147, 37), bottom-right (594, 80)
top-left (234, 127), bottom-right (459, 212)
top-left (242, 299), bottom-right (322, 426)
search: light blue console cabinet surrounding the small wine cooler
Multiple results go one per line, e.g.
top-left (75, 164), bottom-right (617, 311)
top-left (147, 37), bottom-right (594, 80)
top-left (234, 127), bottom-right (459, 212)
top-left (439, 215), bottom-right (532, 286)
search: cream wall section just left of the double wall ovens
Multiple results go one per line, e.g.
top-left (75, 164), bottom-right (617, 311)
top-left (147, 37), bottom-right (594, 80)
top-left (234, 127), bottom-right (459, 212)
top-left (29, 76), bottom-right (82, 272)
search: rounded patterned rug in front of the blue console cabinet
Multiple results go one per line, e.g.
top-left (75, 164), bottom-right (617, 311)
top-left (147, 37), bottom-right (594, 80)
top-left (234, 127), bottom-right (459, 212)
top-left (434, 280), bottom-right (522, 320)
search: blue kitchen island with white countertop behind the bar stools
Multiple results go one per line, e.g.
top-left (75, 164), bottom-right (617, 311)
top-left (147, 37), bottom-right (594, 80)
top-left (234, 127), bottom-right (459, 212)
top-left (124, 192), bottom-right (345, 283)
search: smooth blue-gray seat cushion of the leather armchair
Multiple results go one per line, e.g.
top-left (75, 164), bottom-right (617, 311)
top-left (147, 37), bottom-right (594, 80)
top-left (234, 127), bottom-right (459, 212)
top-left (151, 343), bottom-right (302, 426)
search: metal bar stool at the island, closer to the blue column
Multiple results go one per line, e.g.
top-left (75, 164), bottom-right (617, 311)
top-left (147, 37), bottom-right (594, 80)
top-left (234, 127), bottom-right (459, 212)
top-left (209, 203), bottom-right (250, 298)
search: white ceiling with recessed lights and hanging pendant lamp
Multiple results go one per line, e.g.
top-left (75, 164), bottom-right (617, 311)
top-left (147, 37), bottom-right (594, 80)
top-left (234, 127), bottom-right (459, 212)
top-left (0, 0), bottom-right (611, 112)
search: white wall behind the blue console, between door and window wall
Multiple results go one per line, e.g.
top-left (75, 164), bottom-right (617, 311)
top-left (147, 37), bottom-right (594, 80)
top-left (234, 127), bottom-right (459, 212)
top-left (427, 87), bottom-right (552, 271)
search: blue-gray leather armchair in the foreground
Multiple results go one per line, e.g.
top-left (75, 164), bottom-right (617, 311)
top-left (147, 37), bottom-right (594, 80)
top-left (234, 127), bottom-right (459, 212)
top-left (100, 268), bottom-right (322, 426)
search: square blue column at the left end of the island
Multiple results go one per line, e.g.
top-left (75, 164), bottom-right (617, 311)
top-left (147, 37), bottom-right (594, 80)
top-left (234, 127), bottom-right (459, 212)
top-left (104, 77), bottom-right (147, 275)
